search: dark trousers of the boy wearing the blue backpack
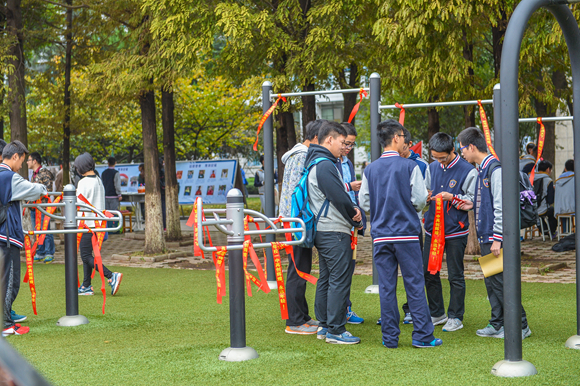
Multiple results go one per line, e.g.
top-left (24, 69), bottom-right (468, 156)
top-left (314, 231), bottom-right (352, 335)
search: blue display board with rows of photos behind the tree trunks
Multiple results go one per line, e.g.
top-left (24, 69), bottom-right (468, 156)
top-left (96, 160), bottom-right (238, 205)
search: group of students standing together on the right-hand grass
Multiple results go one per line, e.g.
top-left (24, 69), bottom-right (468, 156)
top-left (280, 120), bottom-right (535, 348)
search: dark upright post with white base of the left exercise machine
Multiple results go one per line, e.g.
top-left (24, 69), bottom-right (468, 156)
top-left (56, 184), bottom-right (89, 327)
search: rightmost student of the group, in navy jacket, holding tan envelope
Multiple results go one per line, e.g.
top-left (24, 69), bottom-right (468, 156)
top-left (457, 127), bottom-right (532, 339)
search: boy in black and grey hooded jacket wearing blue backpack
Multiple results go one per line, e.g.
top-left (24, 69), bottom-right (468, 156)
top-left (304, 122), bottom-right (362, 344)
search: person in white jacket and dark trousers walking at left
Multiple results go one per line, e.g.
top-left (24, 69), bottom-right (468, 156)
top-left (75, 153), bottom-right (123, 295)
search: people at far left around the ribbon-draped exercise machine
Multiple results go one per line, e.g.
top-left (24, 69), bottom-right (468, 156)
top-left (0, 140), bottom-right (123, 336)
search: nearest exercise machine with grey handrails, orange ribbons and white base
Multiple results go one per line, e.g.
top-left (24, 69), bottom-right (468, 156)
top-left (192, 188), bottom-right (306, 362)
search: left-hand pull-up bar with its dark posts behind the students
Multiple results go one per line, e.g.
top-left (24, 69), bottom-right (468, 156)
top-left (254, 80), bottom-right (370, 293)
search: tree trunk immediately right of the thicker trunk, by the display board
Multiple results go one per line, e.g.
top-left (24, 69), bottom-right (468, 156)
top-left (161, 90), bottom-right (181, 241)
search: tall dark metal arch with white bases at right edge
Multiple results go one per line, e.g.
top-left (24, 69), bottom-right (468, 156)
top-left (491, 0), bottom-right (580, 377)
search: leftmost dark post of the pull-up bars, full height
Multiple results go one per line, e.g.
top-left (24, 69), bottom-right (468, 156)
top-left (262, 81), bottom-right (278, 289)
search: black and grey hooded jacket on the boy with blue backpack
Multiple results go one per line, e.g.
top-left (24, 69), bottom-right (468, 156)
top-left (304, 145), bottom-right (362, 235)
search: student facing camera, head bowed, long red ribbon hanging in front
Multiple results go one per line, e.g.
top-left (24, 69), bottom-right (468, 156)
top-left (423, 132), bottom-right (477, 331)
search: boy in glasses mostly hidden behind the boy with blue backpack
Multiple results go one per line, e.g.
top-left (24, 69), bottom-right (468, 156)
top-left (336, 122), bottom-right (366, 324)
